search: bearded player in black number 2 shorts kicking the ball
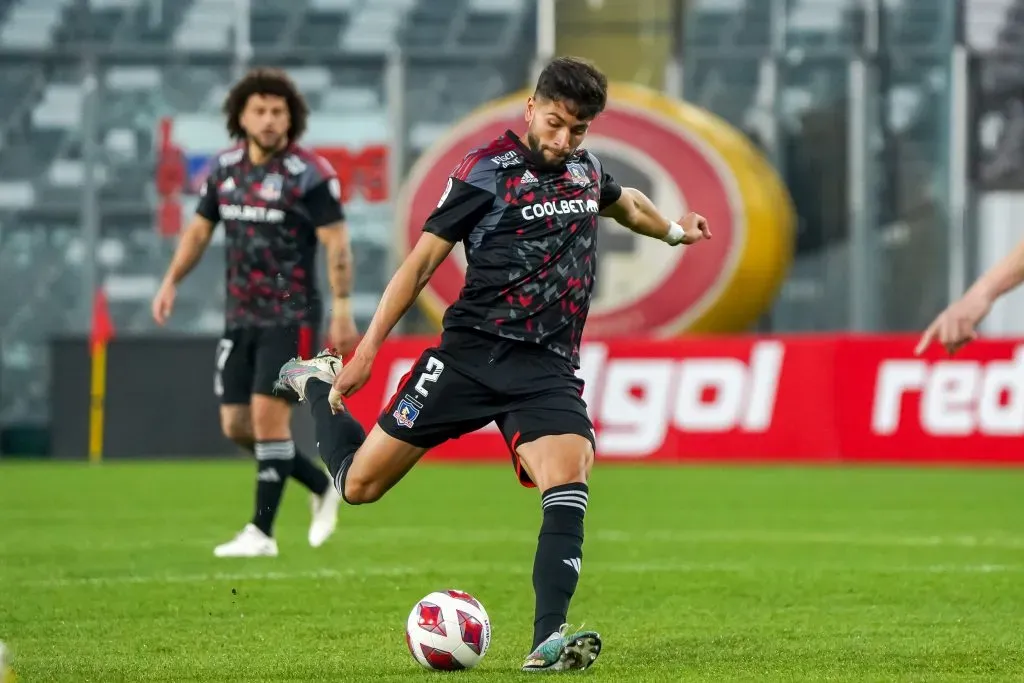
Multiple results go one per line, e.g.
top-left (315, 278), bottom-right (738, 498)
top-left (279, 57), bottom-right (711, 671)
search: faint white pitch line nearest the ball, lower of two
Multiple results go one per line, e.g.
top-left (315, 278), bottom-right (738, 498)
top-left (16, 562), bottom-right (1024, 588)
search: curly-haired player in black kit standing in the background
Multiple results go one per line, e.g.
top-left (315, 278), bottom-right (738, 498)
top-left (153, 69), bottom-right (358, 557)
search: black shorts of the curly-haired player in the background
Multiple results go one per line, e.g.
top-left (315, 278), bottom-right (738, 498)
top-left (220, 325), bottom-right (316, 405)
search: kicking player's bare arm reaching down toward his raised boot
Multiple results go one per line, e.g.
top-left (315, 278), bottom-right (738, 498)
top-left (330, 232), bottom-right (455, 409)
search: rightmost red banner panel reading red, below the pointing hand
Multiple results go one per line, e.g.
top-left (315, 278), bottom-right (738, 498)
top-left (835, 338), bottom-right (1024, 463)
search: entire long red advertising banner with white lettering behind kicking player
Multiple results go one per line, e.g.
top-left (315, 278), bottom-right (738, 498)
top-left (349, 336), bottom-right (1024, 464)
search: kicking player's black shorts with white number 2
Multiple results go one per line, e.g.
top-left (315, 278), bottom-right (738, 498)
top-left (377, 331), bottom-right (596, 486)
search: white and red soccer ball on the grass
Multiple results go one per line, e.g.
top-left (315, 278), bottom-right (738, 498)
top-left (406, 590), bottom-right (490, 671)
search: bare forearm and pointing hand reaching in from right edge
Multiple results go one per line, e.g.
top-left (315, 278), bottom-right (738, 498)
top-left (914, 235), bottom-right (1024, 355)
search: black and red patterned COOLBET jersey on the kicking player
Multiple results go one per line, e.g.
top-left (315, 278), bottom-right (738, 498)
top-left (424, 131), bottom-right (622, 366)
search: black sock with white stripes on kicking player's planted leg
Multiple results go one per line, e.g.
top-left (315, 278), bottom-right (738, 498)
top-left (534, 483), bottom-right (589, 649)
